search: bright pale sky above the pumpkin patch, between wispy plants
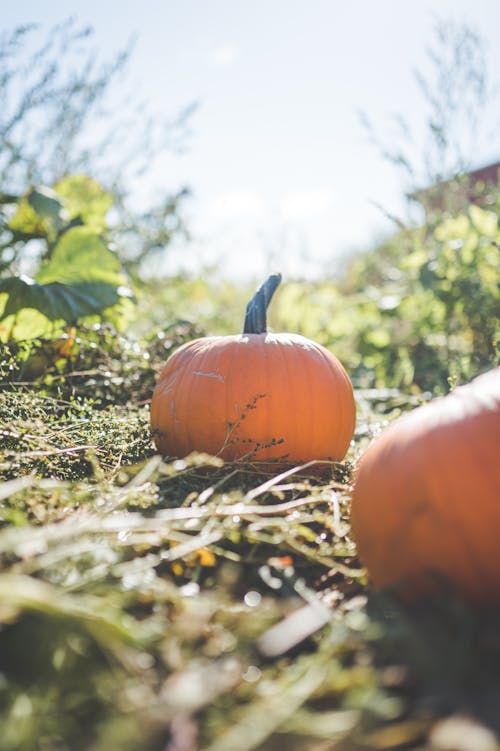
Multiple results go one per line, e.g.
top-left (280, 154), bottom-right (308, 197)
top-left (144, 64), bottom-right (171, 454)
top-left (1, 0), bottom-right (500, 279)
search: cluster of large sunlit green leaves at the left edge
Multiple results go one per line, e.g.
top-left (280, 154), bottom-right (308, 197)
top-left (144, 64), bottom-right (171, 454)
top-left (0, 175), bottom-right (136, 341)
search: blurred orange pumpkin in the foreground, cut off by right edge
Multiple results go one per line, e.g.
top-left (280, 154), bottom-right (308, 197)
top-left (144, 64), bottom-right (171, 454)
top-left (351, 368), bottom-right (500, 603)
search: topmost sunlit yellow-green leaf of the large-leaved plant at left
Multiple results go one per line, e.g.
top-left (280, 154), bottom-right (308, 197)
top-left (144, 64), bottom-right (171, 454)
top-left (54, 175), bottom-right (113, 230)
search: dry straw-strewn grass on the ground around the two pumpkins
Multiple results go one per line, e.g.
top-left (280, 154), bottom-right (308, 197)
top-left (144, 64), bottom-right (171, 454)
top-left (0, 324), bottom-right (500, 751)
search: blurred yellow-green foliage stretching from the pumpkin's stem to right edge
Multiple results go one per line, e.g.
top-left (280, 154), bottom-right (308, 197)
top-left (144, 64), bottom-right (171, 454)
top-left (260, 193), bottom-right (500, 393)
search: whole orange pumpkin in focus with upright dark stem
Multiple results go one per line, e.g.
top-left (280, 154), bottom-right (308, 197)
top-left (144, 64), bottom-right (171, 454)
top-left (151, 274), bottom-right (356, 464)
